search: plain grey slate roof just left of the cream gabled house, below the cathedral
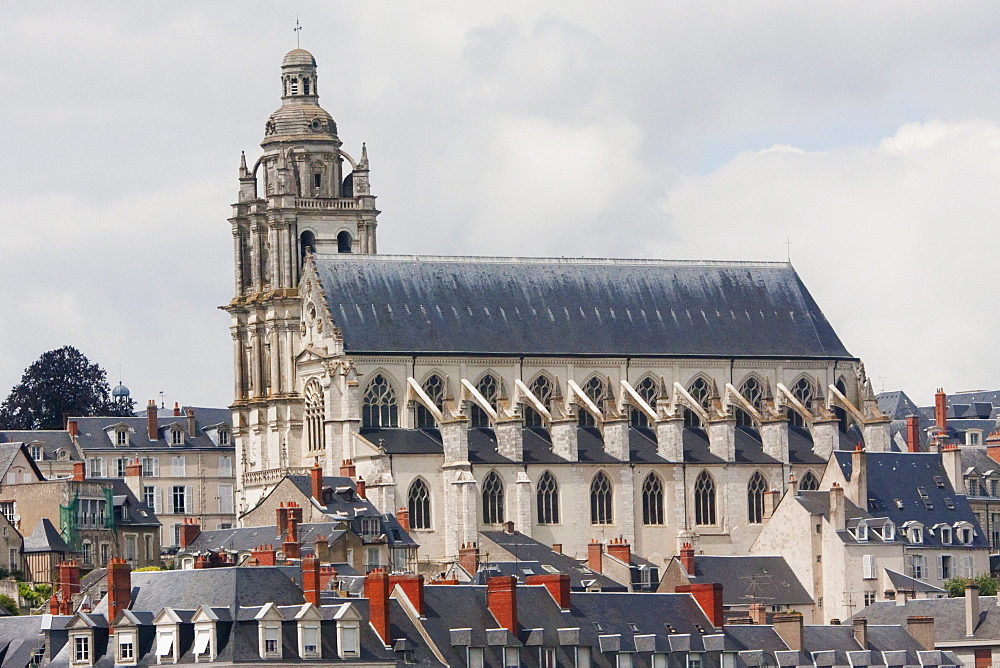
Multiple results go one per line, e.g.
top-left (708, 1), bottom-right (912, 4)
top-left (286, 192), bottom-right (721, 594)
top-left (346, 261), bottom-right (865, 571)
top-left (688, 555), bottom-right (813, 605)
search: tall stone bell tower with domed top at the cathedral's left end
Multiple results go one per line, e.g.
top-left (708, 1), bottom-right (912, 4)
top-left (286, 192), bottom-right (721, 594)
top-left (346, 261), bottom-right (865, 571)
top-left (224, 49), bottom-right (379, 510)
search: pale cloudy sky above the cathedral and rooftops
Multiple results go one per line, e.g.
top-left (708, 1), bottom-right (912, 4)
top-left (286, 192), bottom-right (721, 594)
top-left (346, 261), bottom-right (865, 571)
top-left (0, 0), bottom-right (1000, 406)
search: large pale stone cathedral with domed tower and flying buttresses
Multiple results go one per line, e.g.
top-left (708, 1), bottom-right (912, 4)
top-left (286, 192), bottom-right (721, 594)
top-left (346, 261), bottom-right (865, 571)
top-left (225, 49), bottom-right (891, 564)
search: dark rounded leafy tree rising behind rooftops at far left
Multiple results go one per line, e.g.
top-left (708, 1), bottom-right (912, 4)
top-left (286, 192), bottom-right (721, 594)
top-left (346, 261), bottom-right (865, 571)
top-left (0, 346), bottom-right (135, 429)
